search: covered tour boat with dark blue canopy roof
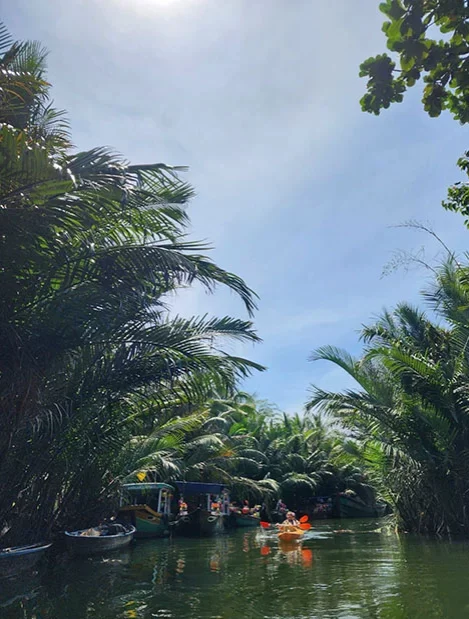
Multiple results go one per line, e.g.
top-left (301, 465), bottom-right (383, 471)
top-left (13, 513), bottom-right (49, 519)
top-left (175, 481), bottom-right (230, 536)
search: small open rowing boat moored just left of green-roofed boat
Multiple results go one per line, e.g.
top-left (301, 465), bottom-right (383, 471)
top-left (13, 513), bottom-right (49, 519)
top-left (65, 523), bottom-right (136, 555)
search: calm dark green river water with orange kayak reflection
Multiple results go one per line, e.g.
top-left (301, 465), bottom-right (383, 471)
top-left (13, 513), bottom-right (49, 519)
top-left (0, 521), bottom-right (469, 619)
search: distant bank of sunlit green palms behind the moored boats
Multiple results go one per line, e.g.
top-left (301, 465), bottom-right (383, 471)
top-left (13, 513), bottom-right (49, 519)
top-left (117, 393), bottom-right (374, 509)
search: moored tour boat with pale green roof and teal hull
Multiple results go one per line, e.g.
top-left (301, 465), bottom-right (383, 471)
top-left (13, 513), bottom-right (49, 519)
top-left (118, 483), bottom-right (174, 538)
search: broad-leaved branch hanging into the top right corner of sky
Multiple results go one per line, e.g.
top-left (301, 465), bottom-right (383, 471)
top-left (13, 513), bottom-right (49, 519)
top-left (360, 0), bottom-right (469, 123)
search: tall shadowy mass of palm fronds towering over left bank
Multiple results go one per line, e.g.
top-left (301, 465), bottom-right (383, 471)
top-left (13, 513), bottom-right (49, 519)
top-left (0, 28), bottom-right (262, 540)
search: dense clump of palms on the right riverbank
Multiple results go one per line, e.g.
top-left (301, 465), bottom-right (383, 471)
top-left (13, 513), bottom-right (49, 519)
top-left (310, 261), bottom-right (469, 534)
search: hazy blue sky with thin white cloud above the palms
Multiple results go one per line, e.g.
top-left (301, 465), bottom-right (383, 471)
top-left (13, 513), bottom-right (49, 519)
top-left (2, 0), bottom-right (469, 412)
